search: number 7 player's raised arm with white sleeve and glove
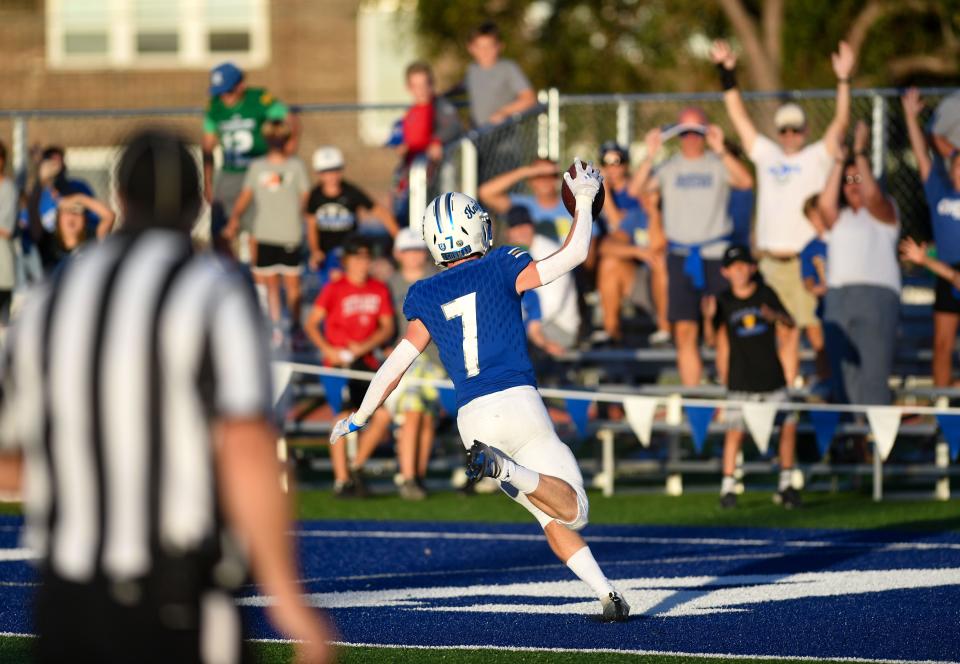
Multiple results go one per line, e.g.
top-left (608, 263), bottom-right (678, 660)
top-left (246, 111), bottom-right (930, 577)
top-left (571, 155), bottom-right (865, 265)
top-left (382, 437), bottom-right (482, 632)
top-left (516, 159), bottom-right (603, 293)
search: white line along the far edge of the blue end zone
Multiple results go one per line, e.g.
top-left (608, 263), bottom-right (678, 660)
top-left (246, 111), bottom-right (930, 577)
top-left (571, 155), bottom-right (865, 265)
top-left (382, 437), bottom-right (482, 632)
top-left (293, 530), bottom-right (960, 551)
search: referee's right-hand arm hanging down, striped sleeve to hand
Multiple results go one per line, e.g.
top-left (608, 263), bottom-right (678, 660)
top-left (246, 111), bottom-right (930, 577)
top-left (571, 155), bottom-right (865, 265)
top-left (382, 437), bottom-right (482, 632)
top-left (211, 280), bottom-right (332, 662)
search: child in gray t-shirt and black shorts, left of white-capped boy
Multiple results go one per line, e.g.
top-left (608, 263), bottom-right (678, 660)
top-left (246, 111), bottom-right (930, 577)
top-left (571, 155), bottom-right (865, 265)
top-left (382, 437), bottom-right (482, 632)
top-left (223, 121), bottom-right (310, 347)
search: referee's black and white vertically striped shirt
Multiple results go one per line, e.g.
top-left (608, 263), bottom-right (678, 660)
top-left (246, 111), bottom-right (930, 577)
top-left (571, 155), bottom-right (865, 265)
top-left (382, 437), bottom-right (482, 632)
top-left (0, 230), bottom-right (271, 582)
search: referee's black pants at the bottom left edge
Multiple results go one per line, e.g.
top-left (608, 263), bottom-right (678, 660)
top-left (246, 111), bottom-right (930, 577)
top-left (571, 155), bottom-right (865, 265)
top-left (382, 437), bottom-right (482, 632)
top-left (33, 573), bottom-right (252, 664)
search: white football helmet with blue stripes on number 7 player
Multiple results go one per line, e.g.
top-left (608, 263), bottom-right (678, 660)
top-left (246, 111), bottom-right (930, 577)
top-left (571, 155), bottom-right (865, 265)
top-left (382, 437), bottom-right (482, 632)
top-left (422, 191), bottom-right (493, 265)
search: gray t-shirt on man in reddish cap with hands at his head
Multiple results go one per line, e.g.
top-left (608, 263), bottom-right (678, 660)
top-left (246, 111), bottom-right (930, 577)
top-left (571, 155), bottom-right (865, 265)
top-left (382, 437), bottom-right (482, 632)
top-left (657, 152), bottom-right (733, 258)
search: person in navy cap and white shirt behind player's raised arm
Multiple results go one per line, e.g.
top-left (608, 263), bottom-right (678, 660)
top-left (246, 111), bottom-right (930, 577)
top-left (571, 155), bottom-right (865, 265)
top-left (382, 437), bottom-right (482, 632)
top-left (492, 205), bottom-right (580, 350)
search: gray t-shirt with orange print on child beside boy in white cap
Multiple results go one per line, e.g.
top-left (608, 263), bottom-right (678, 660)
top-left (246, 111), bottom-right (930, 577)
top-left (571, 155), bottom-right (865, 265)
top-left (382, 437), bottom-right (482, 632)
top-left (243, 157), bottom-right (310, 246)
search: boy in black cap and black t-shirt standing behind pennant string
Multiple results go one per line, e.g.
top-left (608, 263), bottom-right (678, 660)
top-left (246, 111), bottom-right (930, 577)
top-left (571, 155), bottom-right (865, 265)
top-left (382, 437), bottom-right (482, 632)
top-left (716, 245), bottom-right (800, 509)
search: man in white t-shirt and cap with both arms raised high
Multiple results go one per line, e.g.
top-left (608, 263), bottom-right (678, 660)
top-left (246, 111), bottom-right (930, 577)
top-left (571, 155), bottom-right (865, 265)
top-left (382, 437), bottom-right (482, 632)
top-left (711, 41), bottom-right (854, 385)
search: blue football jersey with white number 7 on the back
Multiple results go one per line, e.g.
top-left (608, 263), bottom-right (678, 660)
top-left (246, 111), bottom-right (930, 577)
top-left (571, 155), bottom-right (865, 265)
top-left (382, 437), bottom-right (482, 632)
top-left (403, 247), bottom-right (537, 408)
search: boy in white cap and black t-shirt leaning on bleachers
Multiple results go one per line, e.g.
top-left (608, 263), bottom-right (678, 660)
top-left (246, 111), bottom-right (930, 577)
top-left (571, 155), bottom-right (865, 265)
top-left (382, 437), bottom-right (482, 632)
top-left (307, 145), bottom-right (398, 283)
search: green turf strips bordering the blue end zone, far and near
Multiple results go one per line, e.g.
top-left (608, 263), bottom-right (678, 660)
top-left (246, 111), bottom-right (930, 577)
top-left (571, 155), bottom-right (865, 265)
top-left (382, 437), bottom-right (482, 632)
top-left (0, 491), bottom-right (960, 664)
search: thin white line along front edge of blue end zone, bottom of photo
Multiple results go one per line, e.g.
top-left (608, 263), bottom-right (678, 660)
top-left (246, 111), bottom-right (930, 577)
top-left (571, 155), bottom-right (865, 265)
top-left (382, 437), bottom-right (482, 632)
top-left (248, 639), bottom-right (958, 664)
